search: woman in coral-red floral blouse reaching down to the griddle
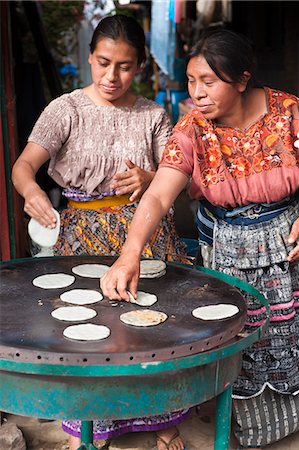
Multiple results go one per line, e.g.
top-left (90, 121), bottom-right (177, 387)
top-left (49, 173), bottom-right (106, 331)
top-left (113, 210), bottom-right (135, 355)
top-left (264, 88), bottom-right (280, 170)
top-left (101, 30), bottom-right (299, 449)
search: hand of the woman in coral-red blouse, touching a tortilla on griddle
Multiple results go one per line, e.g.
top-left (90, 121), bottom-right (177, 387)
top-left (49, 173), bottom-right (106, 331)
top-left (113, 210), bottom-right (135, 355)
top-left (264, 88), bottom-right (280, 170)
top-left (100, 254), bottom-right (140, 301)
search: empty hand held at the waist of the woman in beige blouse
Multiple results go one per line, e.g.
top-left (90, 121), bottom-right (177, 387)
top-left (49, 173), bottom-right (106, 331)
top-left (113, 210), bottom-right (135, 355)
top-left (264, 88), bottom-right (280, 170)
top-left (111, 159), bottom-right (155, 202)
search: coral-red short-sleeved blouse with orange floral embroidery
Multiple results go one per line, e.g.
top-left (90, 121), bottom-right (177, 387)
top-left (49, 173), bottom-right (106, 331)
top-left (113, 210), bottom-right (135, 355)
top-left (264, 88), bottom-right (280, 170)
top-left (160, 87), bottom-right (299, 208)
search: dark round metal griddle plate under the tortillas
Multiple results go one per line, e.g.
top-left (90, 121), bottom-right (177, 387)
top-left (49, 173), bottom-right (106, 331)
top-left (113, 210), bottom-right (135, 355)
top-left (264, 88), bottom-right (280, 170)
top-left (0, 257), bottom-right (246, 365)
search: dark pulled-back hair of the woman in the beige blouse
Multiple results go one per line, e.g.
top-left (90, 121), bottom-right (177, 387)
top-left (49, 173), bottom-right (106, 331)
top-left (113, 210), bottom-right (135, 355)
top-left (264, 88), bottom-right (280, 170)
top-left (89, 14), bottom-right (146, 65)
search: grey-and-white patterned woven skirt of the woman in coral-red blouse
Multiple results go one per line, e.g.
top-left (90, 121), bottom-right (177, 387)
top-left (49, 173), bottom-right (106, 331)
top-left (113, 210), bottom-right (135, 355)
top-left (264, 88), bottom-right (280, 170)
top-left (213, 203), bottom-right (299, 447)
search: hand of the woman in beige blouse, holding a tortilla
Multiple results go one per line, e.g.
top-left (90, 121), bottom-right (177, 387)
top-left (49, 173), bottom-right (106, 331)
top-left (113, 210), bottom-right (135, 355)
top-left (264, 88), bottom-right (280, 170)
top-left (24, 184), bottom-right (56, 228)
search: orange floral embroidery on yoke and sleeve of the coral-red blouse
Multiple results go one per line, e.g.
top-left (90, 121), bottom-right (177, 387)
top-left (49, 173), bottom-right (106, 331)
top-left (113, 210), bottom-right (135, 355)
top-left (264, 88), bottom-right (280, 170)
top-left (162, 87), bottom-right (296, 185)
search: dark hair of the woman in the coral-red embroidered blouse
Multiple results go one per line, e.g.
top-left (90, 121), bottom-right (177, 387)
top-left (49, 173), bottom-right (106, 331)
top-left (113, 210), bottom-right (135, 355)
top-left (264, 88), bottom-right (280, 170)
top-left (187, 29), bottom-right (258, 87)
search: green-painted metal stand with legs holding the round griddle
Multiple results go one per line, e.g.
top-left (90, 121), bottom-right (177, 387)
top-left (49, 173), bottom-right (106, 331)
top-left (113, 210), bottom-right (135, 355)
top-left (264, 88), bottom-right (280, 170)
top-left (0, 267), bottom-right (269, 450)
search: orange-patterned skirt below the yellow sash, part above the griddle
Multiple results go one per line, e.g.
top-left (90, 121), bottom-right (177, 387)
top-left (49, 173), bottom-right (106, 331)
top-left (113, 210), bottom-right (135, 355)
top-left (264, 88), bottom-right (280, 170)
top-left (54, 203), bottom-right (186, 260)
